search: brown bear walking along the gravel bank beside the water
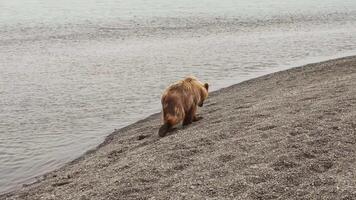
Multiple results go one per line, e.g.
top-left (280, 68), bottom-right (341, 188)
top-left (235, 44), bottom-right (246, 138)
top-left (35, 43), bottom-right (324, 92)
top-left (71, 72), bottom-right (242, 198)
top-left (158, 76), bottom-right (209, 137)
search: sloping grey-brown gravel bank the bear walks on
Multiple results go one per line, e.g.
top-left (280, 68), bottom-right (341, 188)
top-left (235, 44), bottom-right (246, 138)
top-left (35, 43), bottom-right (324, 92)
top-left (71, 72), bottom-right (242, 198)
top-left (0, 57), bottom-right (356, 200)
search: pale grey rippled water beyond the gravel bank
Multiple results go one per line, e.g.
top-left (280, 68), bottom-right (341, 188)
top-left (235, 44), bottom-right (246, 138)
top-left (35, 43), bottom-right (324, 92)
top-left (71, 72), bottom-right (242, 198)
top-left (0, 0), bottom-right (356, 193)
